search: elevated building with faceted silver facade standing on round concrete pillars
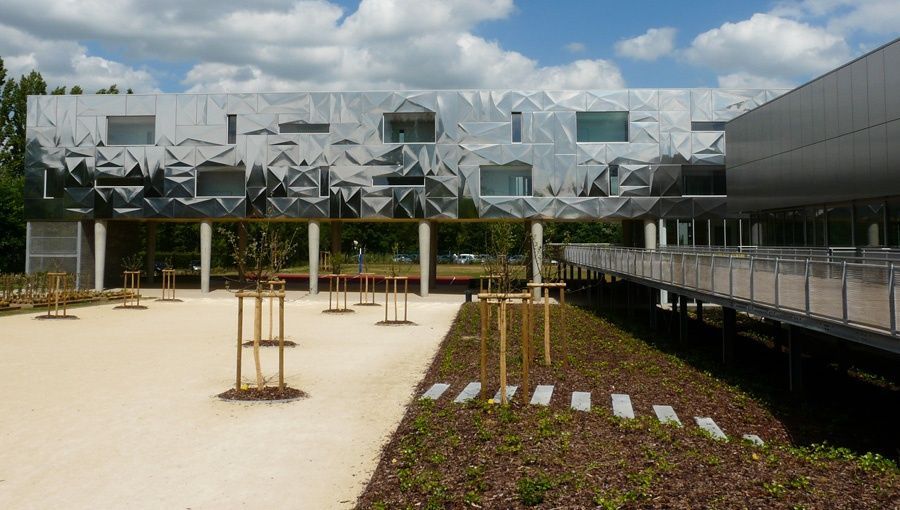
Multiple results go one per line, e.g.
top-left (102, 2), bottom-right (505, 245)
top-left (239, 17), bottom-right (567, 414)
top-left (19, 89), bottom-right (783, 293)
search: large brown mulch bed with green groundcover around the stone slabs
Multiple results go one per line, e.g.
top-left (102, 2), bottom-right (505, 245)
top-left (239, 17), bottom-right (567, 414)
top-left (357, 304), bottom-right (900, 508)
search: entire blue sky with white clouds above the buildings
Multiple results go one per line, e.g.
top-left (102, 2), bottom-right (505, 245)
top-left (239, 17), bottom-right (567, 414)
top-left (0, 0), bottom-right (900, 92)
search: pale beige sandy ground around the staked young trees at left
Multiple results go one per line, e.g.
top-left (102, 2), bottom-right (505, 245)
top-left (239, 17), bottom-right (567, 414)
top-left (0, 291), bottom-right (462, 509)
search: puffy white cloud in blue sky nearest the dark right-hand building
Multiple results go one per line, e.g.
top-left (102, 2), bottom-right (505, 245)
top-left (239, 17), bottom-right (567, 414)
top-left (683, 13), bottom-right (851, 84)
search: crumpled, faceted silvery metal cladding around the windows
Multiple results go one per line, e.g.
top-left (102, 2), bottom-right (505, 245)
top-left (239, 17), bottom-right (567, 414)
top-left (25, 88), bottom-right (780, 220)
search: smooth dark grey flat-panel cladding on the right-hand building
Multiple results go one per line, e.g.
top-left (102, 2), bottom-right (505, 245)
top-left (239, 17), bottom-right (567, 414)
top-left (728, 40), bottom-right (900, 214)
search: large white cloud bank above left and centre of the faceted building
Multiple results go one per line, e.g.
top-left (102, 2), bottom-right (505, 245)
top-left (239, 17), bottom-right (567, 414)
top-left (0, 0), bottom-right (624, 91)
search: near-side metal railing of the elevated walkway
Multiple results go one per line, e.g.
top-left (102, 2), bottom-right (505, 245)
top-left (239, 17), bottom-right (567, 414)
top-left (560, 244), bottom-right (898, 336)
